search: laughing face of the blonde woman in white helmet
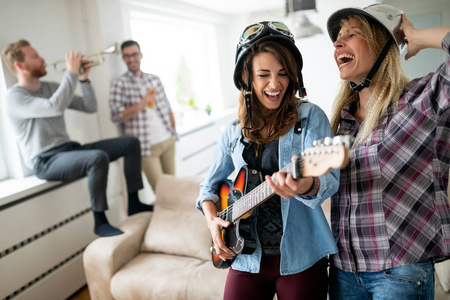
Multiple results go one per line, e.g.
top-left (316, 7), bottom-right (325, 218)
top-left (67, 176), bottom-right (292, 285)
top-left (333, 18), bottom-right (375, 83)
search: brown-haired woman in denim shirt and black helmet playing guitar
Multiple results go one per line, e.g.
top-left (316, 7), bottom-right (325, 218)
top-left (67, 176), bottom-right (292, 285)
top-left (197, 22), bottom-right (339, 300)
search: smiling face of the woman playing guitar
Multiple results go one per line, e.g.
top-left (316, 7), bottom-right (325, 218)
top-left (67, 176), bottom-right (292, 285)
top-left (252, 52), bottom-right (289, 110)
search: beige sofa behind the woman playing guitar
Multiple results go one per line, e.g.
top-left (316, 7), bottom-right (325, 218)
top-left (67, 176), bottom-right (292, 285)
top-left (83, 175), bottom-right (228, 300)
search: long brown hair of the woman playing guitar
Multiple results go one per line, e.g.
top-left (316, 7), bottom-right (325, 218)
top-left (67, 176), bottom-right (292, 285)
top-left (239, 40), bottom-right (299, 155)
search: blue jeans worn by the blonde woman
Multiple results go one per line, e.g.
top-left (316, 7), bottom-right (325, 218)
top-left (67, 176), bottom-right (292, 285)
top-left (329, 259), bottom-right (434, 300)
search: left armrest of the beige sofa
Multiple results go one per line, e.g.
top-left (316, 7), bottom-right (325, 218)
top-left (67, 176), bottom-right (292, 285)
top-left (83, 212), bottom-right (153, 300)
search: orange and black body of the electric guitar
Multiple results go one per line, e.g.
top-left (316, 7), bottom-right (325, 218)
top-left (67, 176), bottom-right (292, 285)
top-left (211, 166), bottom-right (260, 269)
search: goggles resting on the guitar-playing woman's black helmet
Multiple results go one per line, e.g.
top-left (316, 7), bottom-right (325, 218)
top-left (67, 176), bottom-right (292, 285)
top-left (238, 22), bottom-right (294, 47)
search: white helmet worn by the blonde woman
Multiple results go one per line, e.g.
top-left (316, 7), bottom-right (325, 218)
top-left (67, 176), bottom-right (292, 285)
top-left (327, 4), bottom-right (406, 49)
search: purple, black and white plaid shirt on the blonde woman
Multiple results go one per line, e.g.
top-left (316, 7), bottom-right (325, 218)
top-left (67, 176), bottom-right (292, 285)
top-left (331, 33), bottom-right (450, 272)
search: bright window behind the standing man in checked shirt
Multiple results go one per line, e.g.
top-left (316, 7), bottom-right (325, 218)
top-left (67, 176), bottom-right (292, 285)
top-left (130, 12), bottom-right (222, 125)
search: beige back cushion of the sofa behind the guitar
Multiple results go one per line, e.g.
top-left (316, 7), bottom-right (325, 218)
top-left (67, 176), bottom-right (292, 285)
top-left (142, 175), bottom-right (211, 260)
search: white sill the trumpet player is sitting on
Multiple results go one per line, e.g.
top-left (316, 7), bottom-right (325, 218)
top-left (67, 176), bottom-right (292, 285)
top-left (0, 176), bottom-right (62, 210)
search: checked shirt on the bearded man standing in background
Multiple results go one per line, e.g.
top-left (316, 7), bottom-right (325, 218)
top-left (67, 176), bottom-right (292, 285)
top-left (109, 71), bottom-right (178, 156)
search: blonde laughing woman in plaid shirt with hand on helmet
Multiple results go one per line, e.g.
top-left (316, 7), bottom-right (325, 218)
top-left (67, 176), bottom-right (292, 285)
top-left (328, 4), bottom-right (450, 300)
